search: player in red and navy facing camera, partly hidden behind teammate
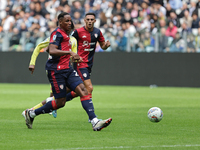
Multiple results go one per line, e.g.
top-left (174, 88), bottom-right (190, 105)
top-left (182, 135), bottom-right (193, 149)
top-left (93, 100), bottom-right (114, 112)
top-left (68, 13), bottom-right (110, 113)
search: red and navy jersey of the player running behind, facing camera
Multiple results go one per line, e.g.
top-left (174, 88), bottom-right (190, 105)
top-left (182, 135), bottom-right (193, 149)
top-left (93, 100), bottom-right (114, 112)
top-left (72, 27), bottom-right (105, 68)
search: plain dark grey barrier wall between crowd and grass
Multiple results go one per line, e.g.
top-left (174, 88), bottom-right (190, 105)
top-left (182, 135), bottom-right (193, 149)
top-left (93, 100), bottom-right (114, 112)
top-left (0, 52), bottom-right (200, 87)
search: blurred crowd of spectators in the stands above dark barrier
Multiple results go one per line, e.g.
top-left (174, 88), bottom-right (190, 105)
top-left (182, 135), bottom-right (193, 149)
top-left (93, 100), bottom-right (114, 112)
top-left (0, 0), bottom-right (200, 52)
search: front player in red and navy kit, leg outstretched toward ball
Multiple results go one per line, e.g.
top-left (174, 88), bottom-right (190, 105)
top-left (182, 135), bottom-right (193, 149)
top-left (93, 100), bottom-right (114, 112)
top-left (25, 12), bottom-right (112, 131)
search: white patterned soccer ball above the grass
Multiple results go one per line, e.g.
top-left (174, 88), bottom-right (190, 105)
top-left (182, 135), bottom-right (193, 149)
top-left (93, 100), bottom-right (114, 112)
top-left (147, 107), bottom-right (163, 122)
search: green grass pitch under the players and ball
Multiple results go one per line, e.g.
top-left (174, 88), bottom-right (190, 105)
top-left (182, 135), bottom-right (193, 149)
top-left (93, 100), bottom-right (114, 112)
top-left (0, 84), bottom-right (200, 150)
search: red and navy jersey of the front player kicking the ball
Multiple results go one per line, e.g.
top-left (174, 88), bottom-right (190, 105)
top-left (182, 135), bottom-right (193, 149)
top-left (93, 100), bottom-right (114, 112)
top-left (46, 27), bottom-right (71, 70)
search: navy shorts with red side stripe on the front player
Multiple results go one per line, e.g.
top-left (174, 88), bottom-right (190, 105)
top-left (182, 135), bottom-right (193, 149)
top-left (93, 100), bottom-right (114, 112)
top-left (47, 68), bottom-right (83, 98)
